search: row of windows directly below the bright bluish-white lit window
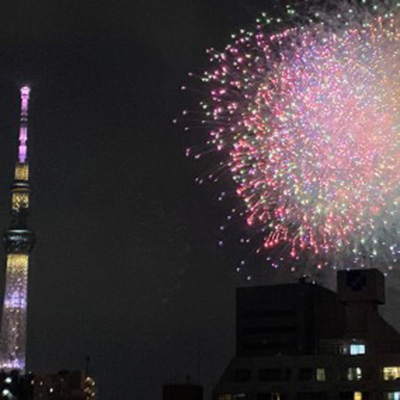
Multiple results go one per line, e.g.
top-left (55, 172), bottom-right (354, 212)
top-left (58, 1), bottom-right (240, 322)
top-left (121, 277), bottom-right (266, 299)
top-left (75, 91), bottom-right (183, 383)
top-left (232, 366), bottom-right (400, 382)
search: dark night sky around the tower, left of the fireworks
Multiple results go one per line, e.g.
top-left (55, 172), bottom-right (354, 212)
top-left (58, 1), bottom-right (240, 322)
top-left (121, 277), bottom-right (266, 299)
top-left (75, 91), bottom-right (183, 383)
top-left (0, 0), bottom-right (400, 400)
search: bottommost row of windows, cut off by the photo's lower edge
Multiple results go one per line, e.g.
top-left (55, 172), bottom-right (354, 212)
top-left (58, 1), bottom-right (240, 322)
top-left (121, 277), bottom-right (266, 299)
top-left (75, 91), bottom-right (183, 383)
top-left (218, 391), bottom-right (400, 400)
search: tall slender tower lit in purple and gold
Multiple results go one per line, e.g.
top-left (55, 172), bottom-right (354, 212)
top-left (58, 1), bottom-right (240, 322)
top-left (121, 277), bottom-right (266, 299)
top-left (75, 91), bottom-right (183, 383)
top-left (0, 86), bottom-right (35, 373)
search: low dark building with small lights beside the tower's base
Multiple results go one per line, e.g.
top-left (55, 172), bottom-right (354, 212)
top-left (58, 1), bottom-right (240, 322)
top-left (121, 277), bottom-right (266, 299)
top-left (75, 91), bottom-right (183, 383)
top-left (33, 371), bottom-right (97, 400)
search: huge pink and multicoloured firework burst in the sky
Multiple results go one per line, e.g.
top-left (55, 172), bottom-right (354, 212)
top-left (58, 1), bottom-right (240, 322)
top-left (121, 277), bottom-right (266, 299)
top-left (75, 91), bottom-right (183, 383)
top-left (188, 2), bottom-right (400, 268)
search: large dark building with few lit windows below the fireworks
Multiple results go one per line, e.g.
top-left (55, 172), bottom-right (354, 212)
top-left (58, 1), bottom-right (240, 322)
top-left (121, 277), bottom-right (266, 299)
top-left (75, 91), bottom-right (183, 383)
top-left (214, 269), bottom-right (400, 400)
